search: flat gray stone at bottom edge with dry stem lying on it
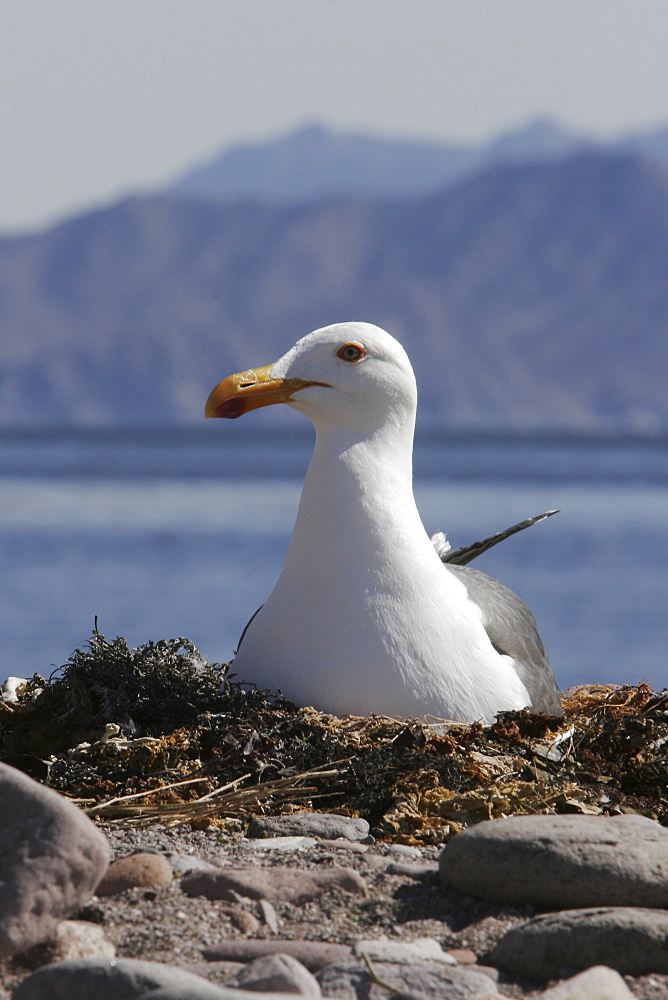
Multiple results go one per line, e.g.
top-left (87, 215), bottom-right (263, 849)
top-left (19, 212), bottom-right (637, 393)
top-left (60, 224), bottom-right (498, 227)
top-left (316, 957), bottom-right (499, 1000)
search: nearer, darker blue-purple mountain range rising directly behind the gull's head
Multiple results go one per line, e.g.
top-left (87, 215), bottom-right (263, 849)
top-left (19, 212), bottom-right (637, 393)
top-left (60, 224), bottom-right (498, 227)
top-left (0, 151), bottom-right (668, 432)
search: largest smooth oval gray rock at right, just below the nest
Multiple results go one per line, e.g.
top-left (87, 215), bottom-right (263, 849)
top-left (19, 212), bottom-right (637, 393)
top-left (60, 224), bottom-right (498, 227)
top-left (440, 815), bottom-right (668, 908)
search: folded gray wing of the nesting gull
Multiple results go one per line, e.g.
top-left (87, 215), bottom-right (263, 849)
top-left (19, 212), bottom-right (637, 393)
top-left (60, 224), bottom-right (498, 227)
top-left (444, 563), bottom-right (563, 715)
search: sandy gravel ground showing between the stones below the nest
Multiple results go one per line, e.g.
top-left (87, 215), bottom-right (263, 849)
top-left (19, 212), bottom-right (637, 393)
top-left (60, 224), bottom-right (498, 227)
top-left (0, 826), bottom-right (668, 1000)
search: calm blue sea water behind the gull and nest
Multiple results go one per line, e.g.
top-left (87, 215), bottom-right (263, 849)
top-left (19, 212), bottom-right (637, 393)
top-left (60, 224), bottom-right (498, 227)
top-left (0, 421), bottom-right (668, 689)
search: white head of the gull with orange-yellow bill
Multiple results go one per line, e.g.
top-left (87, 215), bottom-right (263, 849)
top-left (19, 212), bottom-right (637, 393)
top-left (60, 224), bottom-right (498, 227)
top-left (205, 323), bottom-right (417, 433)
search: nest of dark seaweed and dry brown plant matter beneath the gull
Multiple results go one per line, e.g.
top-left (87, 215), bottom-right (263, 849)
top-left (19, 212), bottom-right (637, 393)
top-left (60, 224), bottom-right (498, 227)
top-left (0, 631), bottom-right (668, 844)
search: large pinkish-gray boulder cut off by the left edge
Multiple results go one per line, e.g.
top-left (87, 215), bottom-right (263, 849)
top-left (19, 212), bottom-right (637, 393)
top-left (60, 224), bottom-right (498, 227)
top-left (0, 764), bottom-right (111, 958)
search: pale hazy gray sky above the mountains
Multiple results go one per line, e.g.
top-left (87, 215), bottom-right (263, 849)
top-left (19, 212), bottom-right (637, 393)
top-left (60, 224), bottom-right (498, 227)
top-left (0, 0), bottom-right (668, 234)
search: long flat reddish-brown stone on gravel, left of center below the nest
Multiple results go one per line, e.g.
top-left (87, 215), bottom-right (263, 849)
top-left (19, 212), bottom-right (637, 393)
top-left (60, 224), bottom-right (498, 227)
top-left (181, 868), bottom-right (367, 905)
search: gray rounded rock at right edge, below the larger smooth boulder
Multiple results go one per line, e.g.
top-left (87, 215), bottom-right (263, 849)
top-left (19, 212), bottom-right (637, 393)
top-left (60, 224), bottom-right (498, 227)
top-left (489, 906), bottom-right (668, 983)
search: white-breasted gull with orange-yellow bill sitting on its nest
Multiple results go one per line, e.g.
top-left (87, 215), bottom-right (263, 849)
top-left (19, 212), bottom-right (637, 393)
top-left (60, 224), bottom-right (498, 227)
top-left (205, 323), bottom-right (562, 724)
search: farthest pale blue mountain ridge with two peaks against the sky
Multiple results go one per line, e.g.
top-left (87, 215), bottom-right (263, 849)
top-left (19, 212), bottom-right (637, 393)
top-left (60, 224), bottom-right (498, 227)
top-left (171, 119), bottom-right (587, 203)
